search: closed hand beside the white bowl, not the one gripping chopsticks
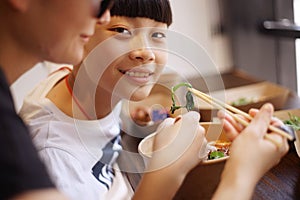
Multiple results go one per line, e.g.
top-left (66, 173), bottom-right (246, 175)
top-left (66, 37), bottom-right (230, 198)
top-left (150, 111), bottom-right (207, 174)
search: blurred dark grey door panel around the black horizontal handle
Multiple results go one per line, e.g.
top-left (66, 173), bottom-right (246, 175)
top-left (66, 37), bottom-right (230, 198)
top-left (219, 0), bottom-right (297, 91)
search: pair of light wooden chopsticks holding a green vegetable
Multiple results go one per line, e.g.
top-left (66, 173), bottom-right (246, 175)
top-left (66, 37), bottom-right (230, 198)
top-left (188, 88), bottom-right (294, 147)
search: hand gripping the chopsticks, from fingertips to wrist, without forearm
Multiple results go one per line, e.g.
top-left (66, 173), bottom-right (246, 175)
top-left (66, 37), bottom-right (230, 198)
top-left (221, 104), bottom-right (289, 188)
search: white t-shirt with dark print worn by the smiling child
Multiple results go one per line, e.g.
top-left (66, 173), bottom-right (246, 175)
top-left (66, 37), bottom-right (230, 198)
top-left (20, 69), bottom-right (133, 200)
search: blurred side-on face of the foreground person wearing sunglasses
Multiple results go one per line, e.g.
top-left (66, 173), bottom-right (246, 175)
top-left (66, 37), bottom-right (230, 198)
top-left (19, 0), bottom-right (110, 64)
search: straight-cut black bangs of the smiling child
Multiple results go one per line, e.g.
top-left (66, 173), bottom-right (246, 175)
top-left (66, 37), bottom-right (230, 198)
top-left (110, 0), bottom-right (172, 26)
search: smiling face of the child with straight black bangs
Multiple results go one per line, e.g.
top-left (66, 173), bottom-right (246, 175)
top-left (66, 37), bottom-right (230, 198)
top-left (86, 16), bottom-right (167, 101)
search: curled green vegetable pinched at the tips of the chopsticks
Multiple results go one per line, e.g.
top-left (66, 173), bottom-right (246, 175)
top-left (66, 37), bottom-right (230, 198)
top-left (170, 83), bottom-right (194, 114)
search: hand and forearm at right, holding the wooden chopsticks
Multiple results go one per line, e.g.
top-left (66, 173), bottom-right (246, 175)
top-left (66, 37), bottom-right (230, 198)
top-left (214, 104), bottom-right (289, 199)
